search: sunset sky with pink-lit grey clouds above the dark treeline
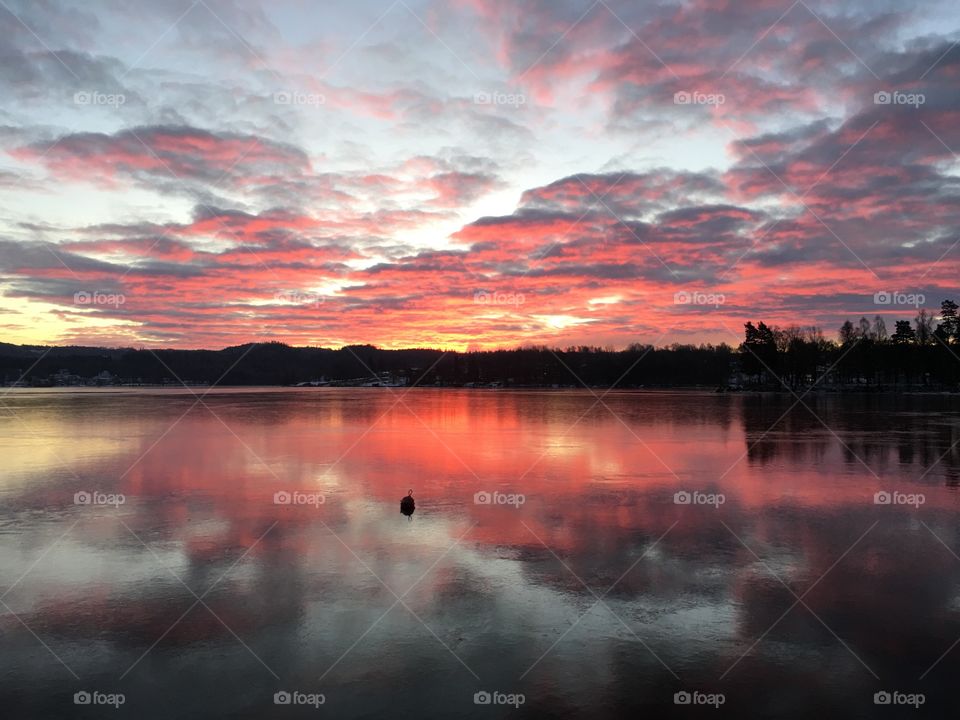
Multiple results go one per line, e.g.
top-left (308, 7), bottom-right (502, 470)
top-left (0, 0), bottom-right (960, 350)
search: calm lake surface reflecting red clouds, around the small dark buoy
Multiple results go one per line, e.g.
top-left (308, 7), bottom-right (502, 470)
top-left (0, 389), bottom-right (960, 718)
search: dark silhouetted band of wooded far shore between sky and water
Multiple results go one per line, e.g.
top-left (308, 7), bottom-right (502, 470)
top-left (0, 300), bottom-right (960, 390)
